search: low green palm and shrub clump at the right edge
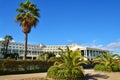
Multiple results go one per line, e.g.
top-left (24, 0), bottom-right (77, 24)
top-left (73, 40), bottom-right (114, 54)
top-left (94, 53), bottom-right (120, 72)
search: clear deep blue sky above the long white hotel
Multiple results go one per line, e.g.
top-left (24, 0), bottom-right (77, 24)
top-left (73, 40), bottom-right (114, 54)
top-left (0, 0), bottom-right (120, 53)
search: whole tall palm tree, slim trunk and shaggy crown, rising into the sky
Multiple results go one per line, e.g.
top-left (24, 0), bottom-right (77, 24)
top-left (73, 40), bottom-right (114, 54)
top-left (16, 0), bottom-right (40, 60)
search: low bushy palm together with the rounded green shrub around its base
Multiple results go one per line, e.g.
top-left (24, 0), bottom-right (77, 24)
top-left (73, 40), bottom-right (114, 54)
top-left (47, 47), bottom-right (88, 80)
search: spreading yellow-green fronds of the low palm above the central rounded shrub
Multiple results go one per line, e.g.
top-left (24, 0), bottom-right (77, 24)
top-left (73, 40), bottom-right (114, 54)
top-left (55, 47), bottom-right (88, 69)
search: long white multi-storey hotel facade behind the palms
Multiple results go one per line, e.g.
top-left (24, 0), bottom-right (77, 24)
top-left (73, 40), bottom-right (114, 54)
top-left (0, 42), bottom-right (108, 60)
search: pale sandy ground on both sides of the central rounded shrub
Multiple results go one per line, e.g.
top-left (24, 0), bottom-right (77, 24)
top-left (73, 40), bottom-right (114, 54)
top-left (0, 69), bottom-right (120, 80)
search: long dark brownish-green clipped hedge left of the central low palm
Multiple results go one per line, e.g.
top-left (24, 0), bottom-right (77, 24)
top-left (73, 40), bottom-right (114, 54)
top-left (0, 60), bottom-right (53, 75)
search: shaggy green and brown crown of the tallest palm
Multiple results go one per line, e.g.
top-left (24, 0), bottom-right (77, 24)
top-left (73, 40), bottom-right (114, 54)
top-left (15, 0), bottom-right (40, 30)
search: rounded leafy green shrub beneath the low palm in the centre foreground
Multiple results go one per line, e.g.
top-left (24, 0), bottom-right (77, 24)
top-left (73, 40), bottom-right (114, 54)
top-left (47, 66), bottom-right (84, 80)
